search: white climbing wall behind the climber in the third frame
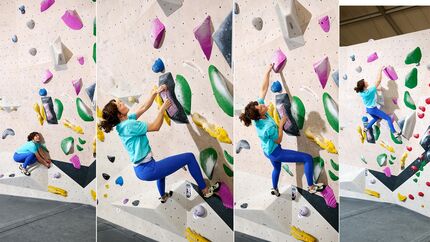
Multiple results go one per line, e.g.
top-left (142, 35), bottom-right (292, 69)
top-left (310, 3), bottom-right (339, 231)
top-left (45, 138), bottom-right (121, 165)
top-left (233, 0), bottom-right (339, 241)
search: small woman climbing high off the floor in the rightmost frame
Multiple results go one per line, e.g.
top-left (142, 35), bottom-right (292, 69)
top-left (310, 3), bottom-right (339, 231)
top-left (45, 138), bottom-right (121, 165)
top-left (354, 67), bottom-right (400, 138)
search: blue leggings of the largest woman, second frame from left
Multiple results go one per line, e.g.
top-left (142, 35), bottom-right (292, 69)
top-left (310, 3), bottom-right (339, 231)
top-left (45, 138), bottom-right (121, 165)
top-left (134, 153), bottom-right (206, 196)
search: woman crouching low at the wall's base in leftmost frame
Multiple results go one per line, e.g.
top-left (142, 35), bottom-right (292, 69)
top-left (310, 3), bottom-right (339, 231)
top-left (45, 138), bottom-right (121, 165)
top-left (13, 132), bottom-right (51, 176)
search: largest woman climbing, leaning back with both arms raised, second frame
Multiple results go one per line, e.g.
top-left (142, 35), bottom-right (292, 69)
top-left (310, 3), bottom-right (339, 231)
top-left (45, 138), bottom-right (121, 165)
top-left (99, 85), bottom-right (220, 203)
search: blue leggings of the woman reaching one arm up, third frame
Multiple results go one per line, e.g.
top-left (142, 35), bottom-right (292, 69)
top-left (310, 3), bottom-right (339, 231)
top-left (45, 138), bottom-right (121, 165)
top-left (265, 145), bottom-right (314, 189)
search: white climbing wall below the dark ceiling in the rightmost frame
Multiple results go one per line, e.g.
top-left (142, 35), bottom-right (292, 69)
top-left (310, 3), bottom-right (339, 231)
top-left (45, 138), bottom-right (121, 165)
top-left (339, 30), bottom-right (430, 216)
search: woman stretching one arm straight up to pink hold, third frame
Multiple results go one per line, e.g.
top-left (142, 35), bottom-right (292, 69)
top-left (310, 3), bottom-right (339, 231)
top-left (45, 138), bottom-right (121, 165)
top-left (239, 64), bottom-right (324, 196)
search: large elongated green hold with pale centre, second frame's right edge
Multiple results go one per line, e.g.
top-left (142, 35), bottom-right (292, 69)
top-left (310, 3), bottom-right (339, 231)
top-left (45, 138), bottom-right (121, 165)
top-left (208, 65), bottom-right (233, 117)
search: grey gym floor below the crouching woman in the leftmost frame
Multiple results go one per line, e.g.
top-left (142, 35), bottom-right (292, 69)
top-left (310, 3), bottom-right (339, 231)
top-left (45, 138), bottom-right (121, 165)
top-left (0, 195), bottom-right (96, 242)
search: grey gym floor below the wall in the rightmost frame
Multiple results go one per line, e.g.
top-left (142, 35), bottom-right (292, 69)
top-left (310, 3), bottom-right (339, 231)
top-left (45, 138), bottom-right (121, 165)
top-left (340, 197), bottom-right (430, 242)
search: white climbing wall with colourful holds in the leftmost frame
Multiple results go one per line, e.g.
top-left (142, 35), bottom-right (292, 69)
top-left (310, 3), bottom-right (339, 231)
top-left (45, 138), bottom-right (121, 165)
top-left (0, 0), bottom-right (96, 205)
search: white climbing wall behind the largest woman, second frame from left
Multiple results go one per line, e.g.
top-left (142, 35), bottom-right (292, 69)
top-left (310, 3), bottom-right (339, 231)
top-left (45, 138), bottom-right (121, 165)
top-left (97, 0), bottom-right (233, 241)
